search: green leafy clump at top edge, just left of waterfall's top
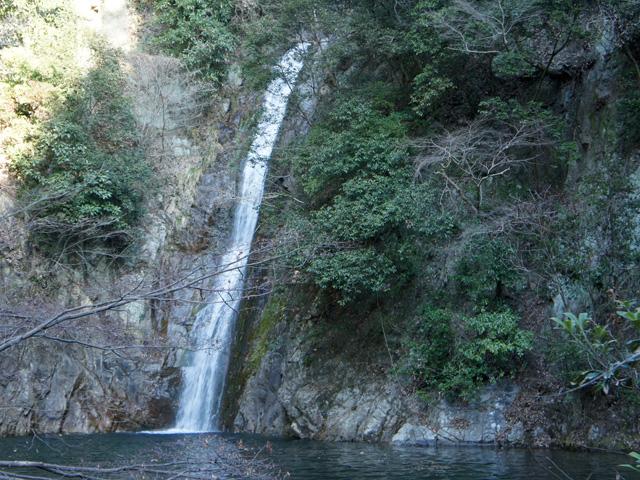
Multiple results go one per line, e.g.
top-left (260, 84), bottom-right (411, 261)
top-left (154, 0), bottom-right (236, 82)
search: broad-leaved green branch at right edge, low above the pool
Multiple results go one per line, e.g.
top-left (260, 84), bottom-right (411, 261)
top-left (553, 301), bottom-right (640, 394)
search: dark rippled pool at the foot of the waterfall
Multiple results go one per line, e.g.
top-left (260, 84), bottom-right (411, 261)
top-left (0, 433), bottom-right (640, 480)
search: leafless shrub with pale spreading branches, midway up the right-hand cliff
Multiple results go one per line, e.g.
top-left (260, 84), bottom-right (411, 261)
top-left (416, 98), bottom-right (576, 216)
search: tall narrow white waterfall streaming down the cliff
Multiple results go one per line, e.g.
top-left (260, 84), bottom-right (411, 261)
top-left (171, 44), bottom-right (308, 432)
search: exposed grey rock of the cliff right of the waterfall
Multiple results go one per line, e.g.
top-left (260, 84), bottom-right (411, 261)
top-left (226, 26), bottom-right (637, 446)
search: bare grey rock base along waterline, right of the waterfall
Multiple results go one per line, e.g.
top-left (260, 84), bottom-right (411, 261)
top-left (234, 332), bottom-right (522, 445)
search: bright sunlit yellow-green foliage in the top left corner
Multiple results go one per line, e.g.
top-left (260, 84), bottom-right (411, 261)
top-left (0, 0), bottom-right (94, 169)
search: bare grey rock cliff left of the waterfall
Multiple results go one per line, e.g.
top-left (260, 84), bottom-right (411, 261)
top-left (0, 1), bottom-right (237, 435)
